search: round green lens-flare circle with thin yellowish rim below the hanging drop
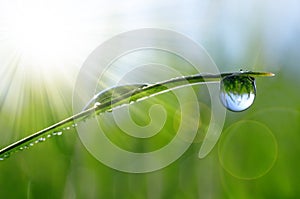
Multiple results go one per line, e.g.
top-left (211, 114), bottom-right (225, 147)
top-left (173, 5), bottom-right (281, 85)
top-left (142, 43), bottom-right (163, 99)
top-left (219, 120), bottom-right (277, 180)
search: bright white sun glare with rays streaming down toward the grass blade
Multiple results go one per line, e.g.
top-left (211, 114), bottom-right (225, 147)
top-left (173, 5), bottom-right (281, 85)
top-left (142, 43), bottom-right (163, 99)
top-left (0, 0), bottom-right (104, 132)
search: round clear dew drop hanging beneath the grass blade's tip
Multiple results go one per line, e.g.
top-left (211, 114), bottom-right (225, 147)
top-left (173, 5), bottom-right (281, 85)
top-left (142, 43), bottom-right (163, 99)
top-left (220, 74), bottom-right (256, 112)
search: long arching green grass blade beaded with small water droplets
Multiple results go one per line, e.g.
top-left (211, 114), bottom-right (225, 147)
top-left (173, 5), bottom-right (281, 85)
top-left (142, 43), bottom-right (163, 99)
top-left (0, 71), bottom-right (274, 160)
